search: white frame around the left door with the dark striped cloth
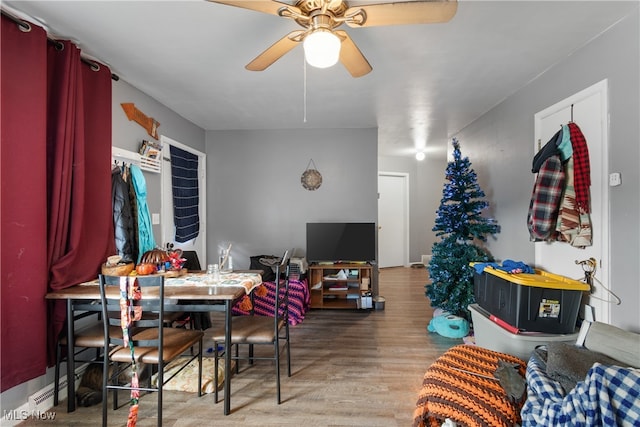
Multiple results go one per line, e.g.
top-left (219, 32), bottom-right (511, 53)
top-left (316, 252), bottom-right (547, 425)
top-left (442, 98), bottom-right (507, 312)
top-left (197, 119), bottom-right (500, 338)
top-left (160, 135), bottom-right (207, 268)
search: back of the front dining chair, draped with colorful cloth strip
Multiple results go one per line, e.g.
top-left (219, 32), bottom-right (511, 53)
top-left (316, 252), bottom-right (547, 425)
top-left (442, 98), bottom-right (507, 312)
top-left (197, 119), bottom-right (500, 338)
top-left (99, 274), bottom-right (165, 351)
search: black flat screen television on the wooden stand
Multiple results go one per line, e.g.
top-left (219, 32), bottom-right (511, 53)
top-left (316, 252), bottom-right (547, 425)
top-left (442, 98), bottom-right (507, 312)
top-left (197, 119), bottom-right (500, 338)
top-left (307, 222), bottom-right (376, 263)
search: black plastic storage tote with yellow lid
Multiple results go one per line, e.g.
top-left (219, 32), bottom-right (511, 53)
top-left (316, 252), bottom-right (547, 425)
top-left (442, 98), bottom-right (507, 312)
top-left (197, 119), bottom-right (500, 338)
top-left (474, 267), bottom-right (590, 334)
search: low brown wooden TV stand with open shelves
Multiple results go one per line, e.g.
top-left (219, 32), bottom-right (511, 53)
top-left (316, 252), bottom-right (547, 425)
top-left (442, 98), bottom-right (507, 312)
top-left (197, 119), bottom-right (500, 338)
top-left (309, 263), bottom-right (372, 309)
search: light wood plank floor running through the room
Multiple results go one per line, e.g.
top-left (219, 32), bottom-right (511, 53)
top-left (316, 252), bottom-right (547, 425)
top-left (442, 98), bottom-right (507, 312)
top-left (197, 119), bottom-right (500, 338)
top-left (20, 268), bottom-right (462, 427)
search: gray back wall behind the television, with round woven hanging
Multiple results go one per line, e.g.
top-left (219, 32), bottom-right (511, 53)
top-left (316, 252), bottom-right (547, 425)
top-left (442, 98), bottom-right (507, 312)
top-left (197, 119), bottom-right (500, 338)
top-left (207, 129), bottom-right (378, 268)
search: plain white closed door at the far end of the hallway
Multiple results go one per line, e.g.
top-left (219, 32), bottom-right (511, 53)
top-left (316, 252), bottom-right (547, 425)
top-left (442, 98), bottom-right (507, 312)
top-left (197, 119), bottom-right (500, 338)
top-left (378, 172), bottom-right (409, 268)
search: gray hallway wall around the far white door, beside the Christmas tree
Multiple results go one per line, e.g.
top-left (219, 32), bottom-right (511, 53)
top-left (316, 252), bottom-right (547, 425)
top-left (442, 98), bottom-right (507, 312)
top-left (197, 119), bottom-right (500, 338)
top-left (378, 149), bottom-right (447, 262)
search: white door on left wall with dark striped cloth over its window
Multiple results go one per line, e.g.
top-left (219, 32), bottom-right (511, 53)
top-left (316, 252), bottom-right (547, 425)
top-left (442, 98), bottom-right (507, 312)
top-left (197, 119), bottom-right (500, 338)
top-left (160, 135), bottom-right (207, 269)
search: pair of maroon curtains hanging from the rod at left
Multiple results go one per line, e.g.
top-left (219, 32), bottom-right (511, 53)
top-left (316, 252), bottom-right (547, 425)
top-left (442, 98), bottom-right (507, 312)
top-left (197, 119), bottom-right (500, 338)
top-left (0, 17), bottom-right (114, 391)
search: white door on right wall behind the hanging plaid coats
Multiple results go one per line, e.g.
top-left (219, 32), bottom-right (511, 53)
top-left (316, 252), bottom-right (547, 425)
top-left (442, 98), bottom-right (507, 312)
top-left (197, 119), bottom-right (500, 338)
top-left (534, 80), bottom-right (612, 323)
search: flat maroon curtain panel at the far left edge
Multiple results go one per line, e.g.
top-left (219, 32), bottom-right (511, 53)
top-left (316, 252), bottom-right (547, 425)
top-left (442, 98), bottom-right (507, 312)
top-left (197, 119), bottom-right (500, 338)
top-left (0, 16), bottom-right (48, 391)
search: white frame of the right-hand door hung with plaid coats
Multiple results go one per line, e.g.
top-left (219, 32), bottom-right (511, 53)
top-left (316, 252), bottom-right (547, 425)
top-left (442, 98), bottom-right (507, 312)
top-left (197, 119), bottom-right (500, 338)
top-left (534, 79), bottom-right (611, 323)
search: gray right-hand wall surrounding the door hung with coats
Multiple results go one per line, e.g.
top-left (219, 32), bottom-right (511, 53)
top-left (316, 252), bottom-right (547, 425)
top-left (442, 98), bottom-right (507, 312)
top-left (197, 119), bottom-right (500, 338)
top-left (457, 9), bottom-right (640, 332)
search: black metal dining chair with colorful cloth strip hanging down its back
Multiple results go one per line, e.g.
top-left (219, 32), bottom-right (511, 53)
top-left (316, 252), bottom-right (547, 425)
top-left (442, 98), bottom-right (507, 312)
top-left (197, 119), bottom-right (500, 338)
top-left (99, 275), bottom-right (204, 426)
